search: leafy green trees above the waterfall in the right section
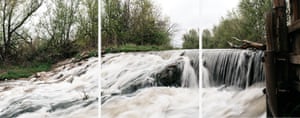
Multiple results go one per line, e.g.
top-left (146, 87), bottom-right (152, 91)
top-left (202, 0), bottom-right (271, 48)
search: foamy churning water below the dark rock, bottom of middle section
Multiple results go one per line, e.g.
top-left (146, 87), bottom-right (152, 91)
top-left (101, 87), bottom-right (199, 118)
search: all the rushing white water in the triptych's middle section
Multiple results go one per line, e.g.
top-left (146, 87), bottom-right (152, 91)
top-left (101, 50), bottom-right (199, 118)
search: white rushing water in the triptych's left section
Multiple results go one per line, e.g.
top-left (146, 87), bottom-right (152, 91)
top-left (0, 57), bottom-right (100, 118)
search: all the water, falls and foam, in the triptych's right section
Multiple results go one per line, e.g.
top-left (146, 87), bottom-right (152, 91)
top-left (201, 49), bottom-right (266, 118)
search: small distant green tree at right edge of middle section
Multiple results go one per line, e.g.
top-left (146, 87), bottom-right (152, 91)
top-left (183, 29), bottom-right (199, 49)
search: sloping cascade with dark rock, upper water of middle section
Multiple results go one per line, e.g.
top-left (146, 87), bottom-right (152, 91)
top-left (101, 50), bottom-right (199, 94)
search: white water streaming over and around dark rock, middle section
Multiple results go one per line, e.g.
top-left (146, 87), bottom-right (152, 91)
top-left (101, 51), bottom-right (198, 92)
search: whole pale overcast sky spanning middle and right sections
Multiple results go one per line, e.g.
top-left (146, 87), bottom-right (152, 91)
top-left (153, 0), bottom-right (240, 47)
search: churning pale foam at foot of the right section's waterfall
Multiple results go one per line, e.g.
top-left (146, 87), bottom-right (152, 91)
top-left (201, 87), bottom-right (266, 118)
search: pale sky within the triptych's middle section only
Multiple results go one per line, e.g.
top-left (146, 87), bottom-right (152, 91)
top-left (152, 0), bottom-right (201, 47)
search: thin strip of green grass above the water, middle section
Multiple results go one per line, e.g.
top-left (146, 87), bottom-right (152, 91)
top-left (102, 44), bottom-right (174, 53)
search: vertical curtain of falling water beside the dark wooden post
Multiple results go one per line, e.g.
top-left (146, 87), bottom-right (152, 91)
top-left (202, 49), bottom-right (265, 88)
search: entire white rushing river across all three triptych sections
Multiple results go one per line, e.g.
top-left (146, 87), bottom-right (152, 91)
top-left (0, 50), bottom-right (266, 118)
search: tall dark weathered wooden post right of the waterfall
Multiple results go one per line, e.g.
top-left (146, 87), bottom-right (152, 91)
top-left (264, 0), bottom-right (289, 117)
